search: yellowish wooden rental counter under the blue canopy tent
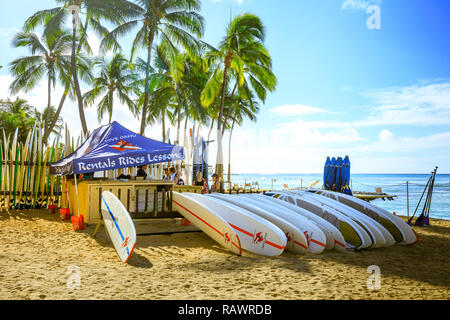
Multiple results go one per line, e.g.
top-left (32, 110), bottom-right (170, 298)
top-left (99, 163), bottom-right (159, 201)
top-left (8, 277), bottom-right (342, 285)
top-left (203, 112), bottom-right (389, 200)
top-left (69, 180), bottom-right (202, 224)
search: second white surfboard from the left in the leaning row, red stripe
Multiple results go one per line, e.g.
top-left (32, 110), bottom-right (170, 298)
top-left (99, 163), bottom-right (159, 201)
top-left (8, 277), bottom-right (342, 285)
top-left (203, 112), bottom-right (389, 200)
top-left (185, 193), bottom-right (287, 257)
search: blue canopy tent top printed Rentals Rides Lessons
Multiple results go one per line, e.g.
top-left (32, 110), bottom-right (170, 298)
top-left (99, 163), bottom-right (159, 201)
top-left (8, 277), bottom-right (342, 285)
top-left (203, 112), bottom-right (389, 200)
top-left (50, 121), bottom-right (185, 176)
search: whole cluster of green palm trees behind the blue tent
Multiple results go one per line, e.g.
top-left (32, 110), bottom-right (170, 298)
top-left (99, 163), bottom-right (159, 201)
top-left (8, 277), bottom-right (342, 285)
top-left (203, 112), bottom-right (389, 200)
top-left (0, 0), bottom-right (277, 177)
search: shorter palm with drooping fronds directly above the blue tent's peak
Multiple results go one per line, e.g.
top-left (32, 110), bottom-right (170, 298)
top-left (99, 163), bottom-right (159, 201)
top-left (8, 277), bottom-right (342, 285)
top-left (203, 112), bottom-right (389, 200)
top-left (83, 53), bottom-right (135, 123)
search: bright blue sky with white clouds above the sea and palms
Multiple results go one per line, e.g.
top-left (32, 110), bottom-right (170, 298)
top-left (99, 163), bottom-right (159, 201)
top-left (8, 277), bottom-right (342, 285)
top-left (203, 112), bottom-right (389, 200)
top-left (0, 0), bottom-right (450, 173)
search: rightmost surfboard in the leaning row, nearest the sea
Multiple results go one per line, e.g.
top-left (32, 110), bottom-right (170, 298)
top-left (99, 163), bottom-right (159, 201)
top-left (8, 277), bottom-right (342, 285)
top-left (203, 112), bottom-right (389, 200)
top-left (308, 190), bottom-right (418, 244)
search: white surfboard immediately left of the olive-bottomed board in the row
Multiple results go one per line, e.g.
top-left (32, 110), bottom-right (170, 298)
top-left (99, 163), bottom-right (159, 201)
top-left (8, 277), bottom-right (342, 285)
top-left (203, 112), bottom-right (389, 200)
top-left (255, 195), bottom-right (346, 252)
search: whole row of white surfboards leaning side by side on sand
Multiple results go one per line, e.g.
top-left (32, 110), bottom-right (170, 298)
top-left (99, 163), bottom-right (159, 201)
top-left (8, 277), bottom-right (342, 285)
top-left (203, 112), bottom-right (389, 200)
top-left (173, 190), bottom-right (417, 256)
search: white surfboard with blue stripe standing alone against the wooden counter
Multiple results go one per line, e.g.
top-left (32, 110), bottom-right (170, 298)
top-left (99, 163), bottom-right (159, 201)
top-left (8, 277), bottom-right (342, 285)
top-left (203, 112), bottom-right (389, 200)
top-left (102, 191), bottom-right (136, 262)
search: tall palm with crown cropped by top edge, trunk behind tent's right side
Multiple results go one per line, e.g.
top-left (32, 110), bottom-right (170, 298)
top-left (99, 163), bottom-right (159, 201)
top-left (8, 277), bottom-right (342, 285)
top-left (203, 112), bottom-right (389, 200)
top-left (101, 0), bottom-right (204, 134)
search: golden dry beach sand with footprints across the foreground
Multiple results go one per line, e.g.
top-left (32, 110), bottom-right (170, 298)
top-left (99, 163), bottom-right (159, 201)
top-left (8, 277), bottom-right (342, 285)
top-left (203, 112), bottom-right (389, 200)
top-left (0, 210), bottom-right (450, 300)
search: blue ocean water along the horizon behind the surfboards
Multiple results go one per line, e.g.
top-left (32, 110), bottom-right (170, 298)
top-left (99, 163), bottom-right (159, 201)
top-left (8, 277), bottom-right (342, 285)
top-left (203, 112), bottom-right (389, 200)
top-left (225, 174), bottom-right (450, 220)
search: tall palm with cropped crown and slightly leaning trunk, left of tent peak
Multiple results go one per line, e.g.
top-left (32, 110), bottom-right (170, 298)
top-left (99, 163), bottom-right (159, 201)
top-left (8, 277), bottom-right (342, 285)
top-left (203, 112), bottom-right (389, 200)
top-left (24, 0), bottom-right (141, 134)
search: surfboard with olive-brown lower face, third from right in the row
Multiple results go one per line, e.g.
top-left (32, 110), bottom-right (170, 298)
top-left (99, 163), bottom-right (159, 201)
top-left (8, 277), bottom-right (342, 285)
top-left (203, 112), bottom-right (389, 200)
top-left (275, 192), bottom-right (372, 249)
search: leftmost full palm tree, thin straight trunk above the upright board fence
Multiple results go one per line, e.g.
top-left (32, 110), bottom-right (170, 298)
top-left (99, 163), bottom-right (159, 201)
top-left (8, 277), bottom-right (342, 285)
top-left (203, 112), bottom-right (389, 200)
top-left (10, 30), bottom-right (72, 142)
